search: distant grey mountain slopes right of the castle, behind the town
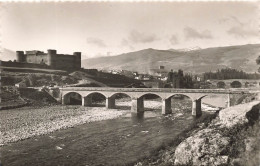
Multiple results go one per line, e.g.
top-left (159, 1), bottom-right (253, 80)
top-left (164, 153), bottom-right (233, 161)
top-left (82, 44), bottom-right (260, 73)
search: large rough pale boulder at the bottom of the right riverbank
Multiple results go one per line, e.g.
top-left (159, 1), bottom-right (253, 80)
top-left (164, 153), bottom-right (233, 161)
top-left (174, 128), bottom-right (230, 165)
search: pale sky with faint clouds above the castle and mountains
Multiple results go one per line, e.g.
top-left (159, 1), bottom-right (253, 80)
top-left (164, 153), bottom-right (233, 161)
top-left (1, 1), bottom-right (260, 59)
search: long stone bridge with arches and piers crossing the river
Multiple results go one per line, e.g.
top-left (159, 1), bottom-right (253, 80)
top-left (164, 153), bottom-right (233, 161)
top-left (60, 87), bottom-right (252, 116)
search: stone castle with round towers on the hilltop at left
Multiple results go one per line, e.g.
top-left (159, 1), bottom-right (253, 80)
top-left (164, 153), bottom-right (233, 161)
top-left (16, 49), bottom-right (81, 70)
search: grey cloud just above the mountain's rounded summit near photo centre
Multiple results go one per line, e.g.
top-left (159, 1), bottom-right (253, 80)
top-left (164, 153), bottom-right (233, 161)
top-left (128, 30), bottom-right (159, 43)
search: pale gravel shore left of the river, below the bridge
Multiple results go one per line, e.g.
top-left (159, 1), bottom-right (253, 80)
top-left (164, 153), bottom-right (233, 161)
top-left (0, 106), bottom-right (129, 146)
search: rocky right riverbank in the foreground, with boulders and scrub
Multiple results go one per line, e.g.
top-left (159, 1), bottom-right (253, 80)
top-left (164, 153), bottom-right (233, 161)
top-left (136, 101), bottom-right (260, 166)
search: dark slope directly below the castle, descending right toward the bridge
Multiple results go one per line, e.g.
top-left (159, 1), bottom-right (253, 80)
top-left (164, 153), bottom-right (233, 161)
top-left (1, 70), bottom-right (140, 87)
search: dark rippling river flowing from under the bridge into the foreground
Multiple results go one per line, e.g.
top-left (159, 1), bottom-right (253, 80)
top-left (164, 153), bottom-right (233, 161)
top-left (1, 99), bottom-right (217, 166)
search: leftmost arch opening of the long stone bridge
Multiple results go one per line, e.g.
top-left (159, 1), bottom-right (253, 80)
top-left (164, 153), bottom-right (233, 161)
top-left (62, 92), bottom-right (82, 105)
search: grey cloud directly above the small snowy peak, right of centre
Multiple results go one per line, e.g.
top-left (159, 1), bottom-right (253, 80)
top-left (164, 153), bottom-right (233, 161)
top-left (183, 27), bottom-right (213, 39)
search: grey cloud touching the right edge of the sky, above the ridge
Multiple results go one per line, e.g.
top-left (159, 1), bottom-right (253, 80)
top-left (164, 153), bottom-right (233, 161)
top-left (227, 26), bottom-right (259, 38)
